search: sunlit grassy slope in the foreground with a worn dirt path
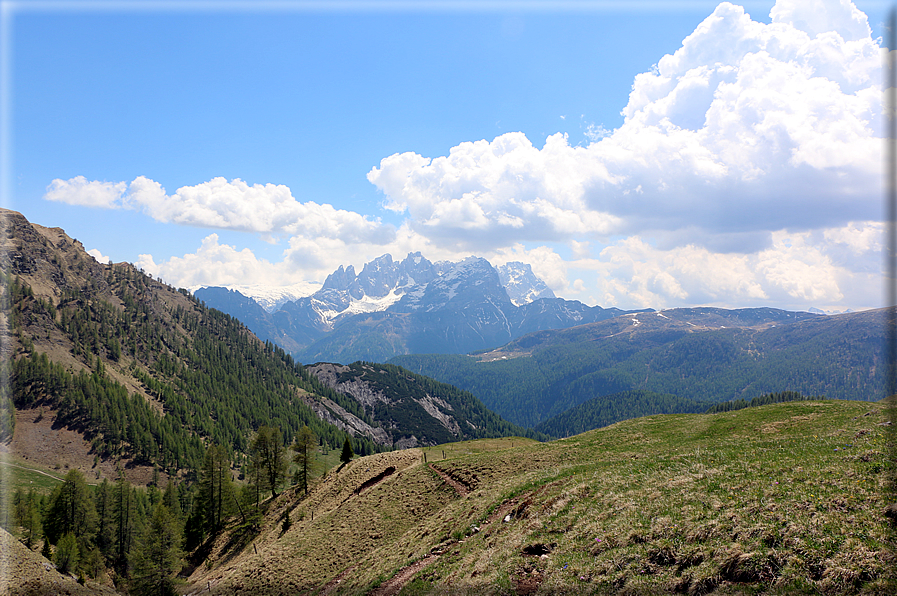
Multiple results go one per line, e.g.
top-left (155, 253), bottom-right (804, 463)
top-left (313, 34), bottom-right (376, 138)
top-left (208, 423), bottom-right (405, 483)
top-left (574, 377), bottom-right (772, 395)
top-left (191, 401), bottom-right (895, 594)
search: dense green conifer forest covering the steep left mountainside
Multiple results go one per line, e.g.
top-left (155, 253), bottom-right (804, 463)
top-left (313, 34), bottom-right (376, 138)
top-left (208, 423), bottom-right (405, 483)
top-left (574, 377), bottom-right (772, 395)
top-left (9, 265), bottom-right (379, 472)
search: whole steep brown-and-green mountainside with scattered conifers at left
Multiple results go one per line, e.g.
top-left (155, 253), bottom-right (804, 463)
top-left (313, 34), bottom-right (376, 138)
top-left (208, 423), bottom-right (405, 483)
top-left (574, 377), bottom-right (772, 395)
top-left (0, 211), bottom-right (528, 480)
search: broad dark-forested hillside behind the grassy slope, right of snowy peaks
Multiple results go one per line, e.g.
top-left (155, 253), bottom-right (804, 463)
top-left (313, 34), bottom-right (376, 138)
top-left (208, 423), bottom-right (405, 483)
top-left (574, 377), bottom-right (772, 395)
top-left (390, 309), bottom-right (885, 434)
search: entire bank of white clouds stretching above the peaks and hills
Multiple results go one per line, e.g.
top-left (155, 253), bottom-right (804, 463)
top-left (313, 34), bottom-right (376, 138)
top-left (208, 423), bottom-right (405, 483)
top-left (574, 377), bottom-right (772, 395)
top-left (44, 0), bottom-right (883, 308)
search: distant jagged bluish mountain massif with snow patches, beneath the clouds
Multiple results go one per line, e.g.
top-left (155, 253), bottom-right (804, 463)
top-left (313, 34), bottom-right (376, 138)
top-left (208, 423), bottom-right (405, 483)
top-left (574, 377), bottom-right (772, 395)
top-left (195, 252), bottom-right (644, 364)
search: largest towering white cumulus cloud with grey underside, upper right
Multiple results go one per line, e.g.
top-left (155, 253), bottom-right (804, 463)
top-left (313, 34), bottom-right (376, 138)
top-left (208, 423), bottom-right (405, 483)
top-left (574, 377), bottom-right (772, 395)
top-left (368, 0), bottom-right (881, 251)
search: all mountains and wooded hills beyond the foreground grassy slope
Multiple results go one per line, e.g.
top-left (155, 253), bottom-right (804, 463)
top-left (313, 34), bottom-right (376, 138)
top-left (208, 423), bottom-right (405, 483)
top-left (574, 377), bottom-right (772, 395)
top-left (2, 205), bottom-right (886, 448)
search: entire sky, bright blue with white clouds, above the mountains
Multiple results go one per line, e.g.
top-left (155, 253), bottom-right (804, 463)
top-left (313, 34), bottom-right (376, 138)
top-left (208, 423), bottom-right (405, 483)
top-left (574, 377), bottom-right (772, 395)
top-left (3, 0), bottom-right (888, 310)
